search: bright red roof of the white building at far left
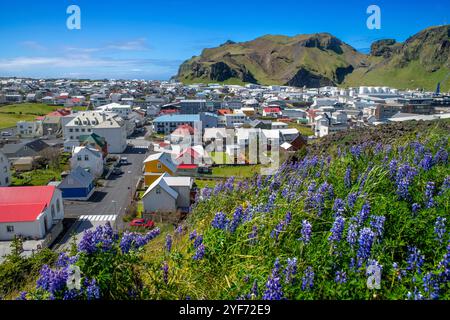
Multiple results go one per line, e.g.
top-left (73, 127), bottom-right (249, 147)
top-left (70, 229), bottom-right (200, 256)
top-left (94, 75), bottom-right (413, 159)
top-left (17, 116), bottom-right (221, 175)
top-left (0, 186), bottom-right (55, 223)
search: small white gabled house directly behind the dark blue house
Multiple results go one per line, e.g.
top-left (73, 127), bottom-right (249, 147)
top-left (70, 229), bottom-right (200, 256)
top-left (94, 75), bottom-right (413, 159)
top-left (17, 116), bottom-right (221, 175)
top-left (70, 147), bottom-right (103, 178)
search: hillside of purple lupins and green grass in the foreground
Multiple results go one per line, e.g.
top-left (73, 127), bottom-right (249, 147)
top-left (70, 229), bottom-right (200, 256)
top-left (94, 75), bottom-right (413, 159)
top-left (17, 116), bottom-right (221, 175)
top-left (7, 121), bottom-right (450, 300)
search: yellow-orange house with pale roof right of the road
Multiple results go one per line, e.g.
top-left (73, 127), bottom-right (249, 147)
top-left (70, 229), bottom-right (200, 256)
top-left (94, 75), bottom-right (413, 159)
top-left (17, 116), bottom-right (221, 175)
top-left (144, 152), bottom-right (177, 186)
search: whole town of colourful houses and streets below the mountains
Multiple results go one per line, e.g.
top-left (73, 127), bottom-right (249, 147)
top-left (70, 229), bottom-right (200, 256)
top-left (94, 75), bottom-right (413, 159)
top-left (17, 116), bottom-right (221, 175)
top-left (0, 78), bottom-right (450, 259)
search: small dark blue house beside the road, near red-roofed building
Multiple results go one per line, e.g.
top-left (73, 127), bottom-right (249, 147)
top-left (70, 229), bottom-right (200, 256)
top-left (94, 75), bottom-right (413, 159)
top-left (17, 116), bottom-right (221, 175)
top-left (58, 167), bottom-right (95, 201)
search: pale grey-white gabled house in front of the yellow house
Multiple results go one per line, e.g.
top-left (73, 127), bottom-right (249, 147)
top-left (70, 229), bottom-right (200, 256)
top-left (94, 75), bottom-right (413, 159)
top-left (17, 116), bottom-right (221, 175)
top-left (142, 174), bottom-right (194, 213)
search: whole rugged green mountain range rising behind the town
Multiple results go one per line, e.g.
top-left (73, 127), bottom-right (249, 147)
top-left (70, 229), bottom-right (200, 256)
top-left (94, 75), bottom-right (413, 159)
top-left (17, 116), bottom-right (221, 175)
top-left (176, 25), bottom-right (450, 90)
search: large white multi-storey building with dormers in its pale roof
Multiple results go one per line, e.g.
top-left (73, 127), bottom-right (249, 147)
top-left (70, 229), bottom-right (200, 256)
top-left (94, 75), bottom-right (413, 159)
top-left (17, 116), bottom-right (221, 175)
top-left (62, 111), bottom-right (127, 153)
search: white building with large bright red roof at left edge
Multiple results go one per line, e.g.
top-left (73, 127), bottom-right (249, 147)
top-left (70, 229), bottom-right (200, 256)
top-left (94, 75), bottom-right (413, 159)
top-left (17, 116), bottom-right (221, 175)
top-left (0, 186), bottom-right (64, 241)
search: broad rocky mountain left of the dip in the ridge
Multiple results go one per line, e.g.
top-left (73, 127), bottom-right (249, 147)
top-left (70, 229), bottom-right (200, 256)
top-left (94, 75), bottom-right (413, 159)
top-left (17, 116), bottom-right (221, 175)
top-left (177, 33), bottom-right (364, 86)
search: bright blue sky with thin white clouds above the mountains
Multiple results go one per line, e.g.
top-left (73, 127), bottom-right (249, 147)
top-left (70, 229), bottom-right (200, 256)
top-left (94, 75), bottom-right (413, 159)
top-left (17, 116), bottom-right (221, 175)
top-left (0, 0), bottom-right (450, 79)
